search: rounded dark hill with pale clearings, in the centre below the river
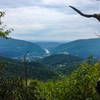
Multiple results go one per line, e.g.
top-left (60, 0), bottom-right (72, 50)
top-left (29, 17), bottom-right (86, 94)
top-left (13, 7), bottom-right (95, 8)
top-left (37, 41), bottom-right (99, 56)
top-left (39, 54), bottom-right (84, 75)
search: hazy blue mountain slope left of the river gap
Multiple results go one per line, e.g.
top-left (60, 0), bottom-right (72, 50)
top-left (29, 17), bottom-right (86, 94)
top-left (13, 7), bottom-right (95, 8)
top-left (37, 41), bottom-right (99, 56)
top-left (0, 38), bottom-right (45, 57)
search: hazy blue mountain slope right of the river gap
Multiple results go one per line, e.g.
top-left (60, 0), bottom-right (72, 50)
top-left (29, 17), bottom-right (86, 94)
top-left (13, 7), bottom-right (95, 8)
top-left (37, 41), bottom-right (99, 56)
top-left (51, 38), bottom-right (100, 58)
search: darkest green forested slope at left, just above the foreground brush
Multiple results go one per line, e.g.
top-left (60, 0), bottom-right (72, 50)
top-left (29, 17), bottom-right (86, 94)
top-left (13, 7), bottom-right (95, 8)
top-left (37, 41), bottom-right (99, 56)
top-left (0, 57), bottom-right (57, 80)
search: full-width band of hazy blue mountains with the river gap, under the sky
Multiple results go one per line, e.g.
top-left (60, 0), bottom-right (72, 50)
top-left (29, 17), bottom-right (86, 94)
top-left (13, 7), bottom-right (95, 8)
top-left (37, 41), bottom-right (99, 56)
top-left (0, 38), bottom-right (100, 59)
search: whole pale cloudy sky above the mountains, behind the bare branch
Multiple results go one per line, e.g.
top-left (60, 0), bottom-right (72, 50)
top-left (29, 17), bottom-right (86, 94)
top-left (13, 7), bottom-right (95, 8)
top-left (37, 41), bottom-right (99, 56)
top-left (0, 0), bottom-right (100, 41)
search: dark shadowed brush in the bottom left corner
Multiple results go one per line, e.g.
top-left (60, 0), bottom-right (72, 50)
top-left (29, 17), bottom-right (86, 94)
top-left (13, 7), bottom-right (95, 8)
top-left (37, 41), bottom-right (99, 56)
top-left (0, 78), bottom-right (38, 100)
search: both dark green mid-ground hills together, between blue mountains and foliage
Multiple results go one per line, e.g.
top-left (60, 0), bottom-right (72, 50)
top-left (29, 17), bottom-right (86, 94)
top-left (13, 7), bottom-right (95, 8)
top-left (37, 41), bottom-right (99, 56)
top-left (0, 54), bottom-right (83, 80)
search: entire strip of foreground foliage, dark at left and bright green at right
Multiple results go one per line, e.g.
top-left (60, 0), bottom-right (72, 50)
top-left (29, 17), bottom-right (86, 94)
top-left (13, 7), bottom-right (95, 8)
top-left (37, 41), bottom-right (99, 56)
top-left (0, 63), bottom-right (100, 100)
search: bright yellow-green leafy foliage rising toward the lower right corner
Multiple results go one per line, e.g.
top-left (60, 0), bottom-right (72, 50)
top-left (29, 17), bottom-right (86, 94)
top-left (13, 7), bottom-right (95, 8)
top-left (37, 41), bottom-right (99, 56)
top-left (38, 63), bottom-right (100, 100)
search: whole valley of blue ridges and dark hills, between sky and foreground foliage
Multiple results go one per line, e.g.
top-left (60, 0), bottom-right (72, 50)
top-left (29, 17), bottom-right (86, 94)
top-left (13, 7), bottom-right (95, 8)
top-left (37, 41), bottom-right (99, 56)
top-left (0, 38), bottom-right (100, 80)
